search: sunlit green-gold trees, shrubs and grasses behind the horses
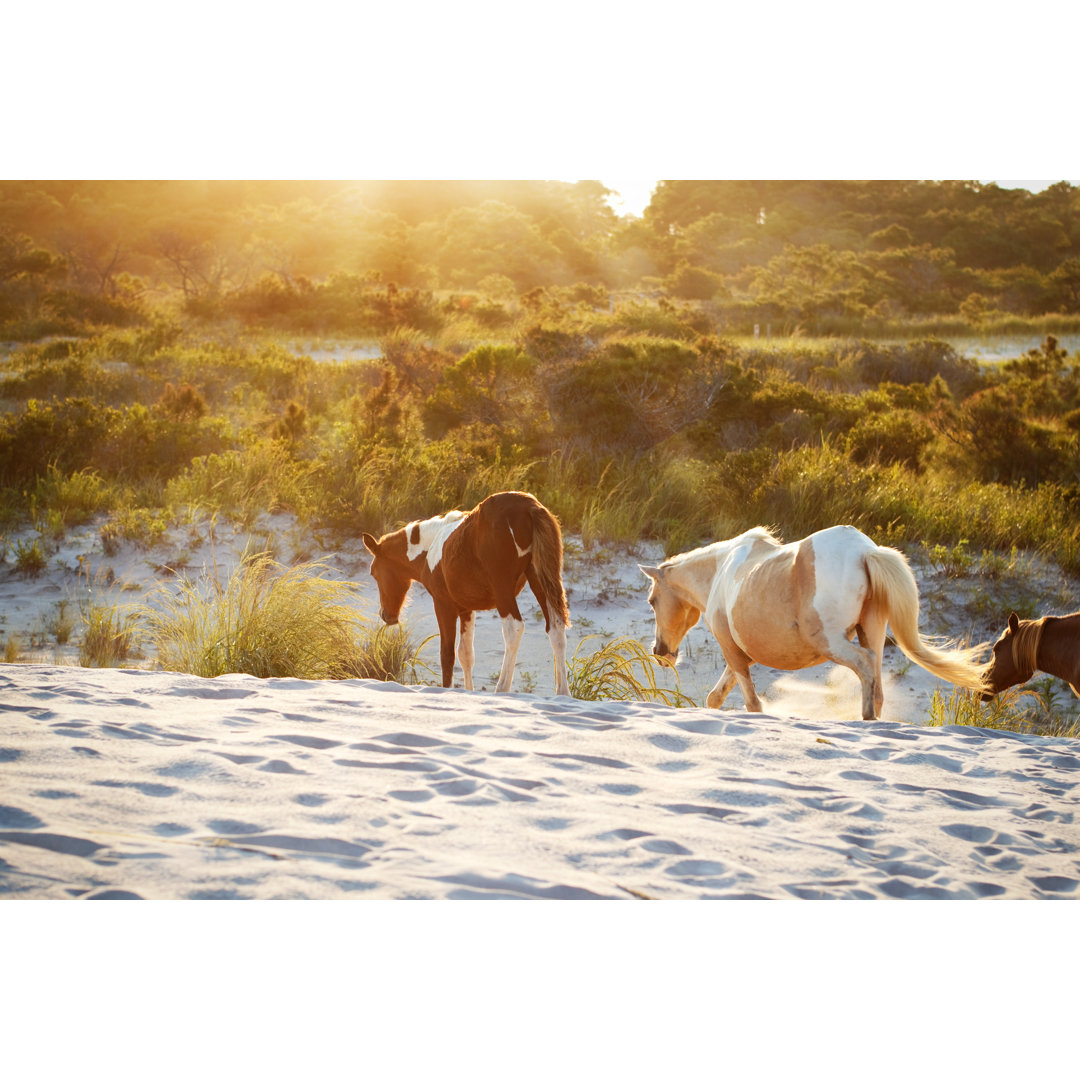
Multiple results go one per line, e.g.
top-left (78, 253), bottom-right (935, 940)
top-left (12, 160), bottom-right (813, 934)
top-left (0, 180), bottom-right (1080, 734)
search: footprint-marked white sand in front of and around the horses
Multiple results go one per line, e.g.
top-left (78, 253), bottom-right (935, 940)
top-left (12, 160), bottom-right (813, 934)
top-left (0, 509), bottom-right (1080, 900)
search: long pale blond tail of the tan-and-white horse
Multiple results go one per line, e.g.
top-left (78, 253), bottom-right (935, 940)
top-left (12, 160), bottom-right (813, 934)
top-left (866, 548), bottom-right (987, 692)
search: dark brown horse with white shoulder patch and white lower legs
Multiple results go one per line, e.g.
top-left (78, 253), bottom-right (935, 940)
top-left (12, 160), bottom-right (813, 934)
top-left (364, 491), bottom-right (570, 696)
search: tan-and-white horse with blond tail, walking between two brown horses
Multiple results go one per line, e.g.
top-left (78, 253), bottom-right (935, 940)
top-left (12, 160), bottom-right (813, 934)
top-left (640, 525), bottom-right (985, 720)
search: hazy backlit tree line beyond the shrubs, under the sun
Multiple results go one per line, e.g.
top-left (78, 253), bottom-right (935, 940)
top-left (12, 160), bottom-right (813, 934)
top-left (0, 180), bottom-right (1080, 339)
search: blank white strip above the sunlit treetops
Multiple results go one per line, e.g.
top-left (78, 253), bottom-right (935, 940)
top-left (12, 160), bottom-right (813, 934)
top-left (6, 6), bottom-right (1080, 198)
